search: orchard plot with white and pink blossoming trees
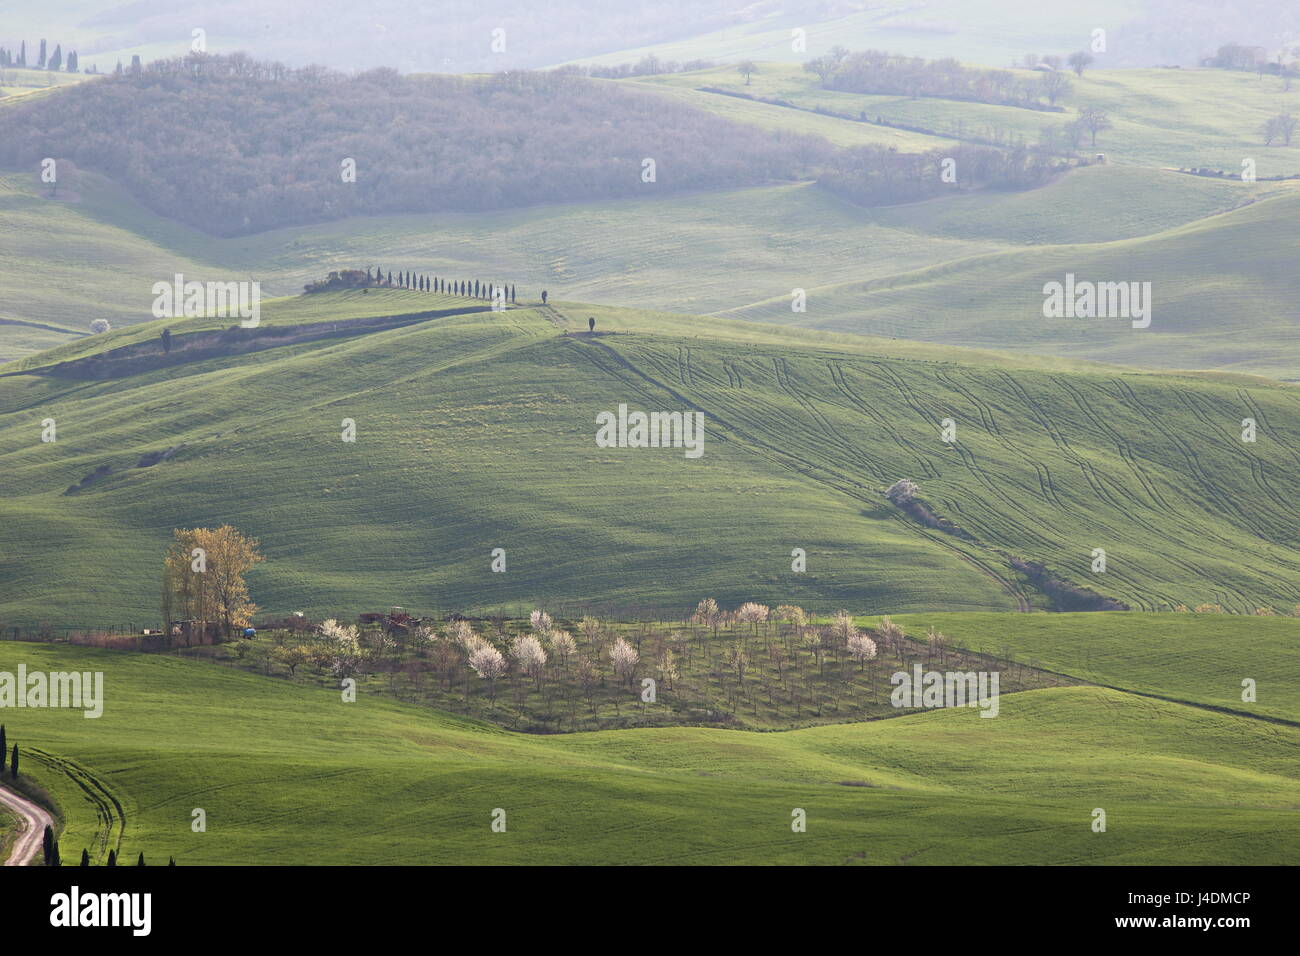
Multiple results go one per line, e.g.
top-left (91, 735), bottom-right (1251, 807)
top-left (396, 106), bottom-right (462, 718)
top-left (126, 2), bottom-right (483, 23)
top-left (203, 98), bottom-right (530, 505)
top-left (183, 598), bottom-right (1057, 732)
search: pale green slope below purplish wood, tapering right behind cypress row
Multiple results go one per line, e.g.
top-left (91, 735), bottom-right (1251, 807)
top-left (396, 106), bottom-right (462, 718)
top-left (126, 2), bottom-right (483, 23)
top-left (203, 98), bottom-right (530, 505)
top-left (0, 166), bottom-right (1001, 359)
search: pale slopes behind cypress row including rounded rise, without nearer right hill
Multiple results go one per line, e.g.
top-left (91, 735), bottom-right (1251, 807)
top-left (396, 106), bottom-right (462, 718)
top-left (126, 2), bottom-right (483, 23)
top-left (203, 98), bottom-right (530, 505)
top-left (0, 158), bottom-right (1269, 364)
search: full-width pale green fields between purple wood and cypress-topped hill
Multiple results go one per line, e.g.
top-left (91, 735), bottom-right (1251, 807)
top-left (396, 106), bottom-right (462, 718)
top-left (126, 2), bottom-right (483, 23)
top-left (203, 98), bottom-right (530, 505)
top-left (0, 157), bottom-right (1300, 378)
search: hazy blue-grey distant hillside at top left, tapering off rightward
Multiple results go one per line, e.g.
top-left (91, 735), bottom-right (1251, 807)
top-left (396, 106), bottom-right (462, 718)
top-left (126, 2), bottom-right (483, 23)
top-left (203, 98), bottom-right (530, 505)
top-left (0, 0), bottom-right (852, 73)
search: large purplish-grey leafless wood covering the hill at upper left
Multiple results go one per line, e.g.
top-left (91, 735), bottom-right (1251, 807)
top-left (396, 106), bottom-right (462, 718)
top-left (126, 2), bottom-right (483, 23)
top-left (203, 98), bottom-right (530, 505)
top-left (0, 53), bottom-right (831, 235)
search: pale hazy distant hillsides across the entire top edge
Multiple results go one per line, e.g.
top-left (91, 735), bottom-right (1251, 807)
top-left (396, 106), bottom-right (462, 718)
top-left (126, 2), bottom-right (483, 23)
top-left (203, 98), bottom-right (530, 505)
top-left (0, 0), bottom-right (1300, 73)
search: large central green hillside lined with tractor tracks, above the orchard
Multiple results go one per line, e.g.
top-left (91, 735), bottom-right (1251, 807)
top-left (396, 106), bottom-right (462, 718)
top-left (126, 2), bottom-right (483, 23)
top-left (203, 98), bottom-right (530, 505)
top-left (0, 294), bottom-right (1300, 624)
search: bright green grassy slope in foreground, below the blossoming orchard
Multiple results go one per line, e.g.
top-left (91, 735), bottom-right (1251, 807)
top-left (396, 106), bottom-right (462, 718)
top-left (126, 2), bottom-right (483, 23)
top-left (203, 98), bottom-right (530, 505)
top-left (0, 644), bottom-right (1300, 864)
